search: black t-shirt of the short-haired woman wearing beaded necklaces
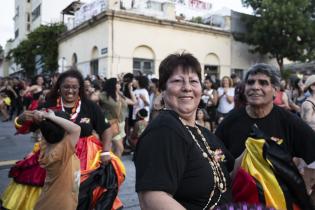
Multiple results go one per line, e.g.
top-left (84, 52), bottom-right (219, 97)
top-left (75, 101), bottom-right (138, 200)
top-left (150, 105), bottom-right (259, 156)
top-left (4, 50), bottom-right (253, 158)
top-left (134, 111), bottom-right (234, 209)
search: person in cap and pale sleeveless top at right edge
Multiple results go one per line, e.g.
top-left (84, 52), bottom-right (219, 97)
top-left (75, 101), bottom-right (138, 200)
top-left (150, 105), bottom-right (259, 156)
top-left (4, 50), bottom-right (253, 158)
top-left (301, 75), bottom-right (315, 130)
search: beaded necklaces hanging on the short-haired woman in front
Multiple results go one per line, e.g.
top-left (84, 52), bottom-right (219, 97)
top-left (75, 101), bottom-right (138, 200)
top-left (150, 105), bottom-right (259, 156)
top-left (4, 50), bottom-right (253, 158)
top-left (179, 118), bottom-right (227, 210)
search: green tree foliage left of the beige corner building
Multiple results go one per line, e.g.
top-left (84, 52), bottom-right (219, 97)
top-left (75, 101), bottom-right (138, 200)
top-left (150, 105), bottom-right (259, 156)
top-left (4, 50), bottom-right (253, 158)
top-left (10, 24), bottom-right (65, 76)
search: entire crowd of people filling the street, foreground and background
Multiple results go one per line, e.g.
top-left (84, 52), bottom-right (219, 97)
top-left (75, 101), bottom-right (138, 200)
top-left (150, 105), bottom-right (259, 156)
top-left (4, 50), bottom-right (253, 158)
top-left (0, 53), bottom-right (315, 210)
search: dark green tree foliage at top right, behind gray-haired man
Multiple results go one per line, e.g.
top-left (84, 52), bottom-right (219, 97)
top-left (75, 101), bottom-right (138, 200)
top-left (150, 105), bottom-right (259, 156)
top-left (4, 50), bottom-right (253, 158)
top-left (236, 0), bottom-right (315, 69)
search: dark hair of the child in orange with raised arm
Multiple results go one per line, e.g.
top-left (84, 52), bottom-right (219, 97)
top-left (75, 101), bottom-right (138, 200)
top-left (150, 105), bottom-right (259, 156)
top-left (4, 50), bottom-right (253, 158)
top-left (39, 111), bottom-right (70, 144)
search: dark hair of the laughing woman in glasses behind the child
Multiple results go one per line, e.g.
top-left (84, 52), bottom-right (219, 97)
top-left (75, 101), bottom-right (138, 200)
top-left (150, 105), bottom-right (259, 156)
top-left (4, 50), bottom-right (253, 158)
top-left (47, 67), bottom-right (86, 100)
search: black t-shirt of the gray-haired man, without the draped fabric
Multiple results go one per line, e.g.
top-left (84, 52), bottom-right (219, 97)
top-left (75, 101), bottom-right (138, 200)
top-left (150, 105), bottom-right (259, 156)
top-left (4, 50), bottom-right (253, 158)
top-left (215, 106), bottom-right (315, 163)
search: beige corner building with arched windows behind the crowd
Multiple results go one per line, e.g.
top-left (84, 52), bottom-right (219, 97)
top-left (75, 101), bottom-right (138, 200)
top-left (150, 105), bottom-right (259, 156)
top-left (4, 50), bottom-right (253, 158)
top-left (59, 1), bottom-right (276, 78)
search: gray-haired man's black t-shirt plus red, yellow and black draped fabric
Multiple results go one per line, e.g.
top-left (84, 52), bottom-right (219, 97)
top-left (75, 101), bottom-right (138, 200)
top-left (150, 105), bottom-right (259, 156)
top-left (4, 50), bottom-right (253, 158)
top-left (216, 106), bottom-right (315, 210)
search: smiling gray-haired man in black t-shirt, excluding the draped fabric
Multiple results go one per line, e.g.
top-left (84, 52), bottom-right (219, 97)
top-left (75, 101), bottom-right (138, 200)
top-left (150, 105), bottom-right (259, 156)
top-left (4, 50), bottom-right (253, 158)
top-left (216, 64), bottom-right (315, 164)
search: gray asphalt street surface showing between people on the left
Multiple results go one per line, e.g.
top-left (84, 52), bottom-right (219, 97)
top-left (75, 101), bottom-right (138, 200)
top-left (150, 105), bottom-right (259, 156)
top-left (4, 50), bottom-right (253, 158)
top-left (0, 122), bottom-right (140, 210)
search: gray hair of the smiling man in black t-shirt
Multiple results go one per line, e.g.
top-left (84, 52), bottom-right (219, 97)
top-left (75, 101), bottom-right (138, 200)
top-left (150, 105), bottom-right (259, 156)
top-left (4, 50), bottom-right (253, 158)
top-left (245, 63), bottom-right (280, 87)
